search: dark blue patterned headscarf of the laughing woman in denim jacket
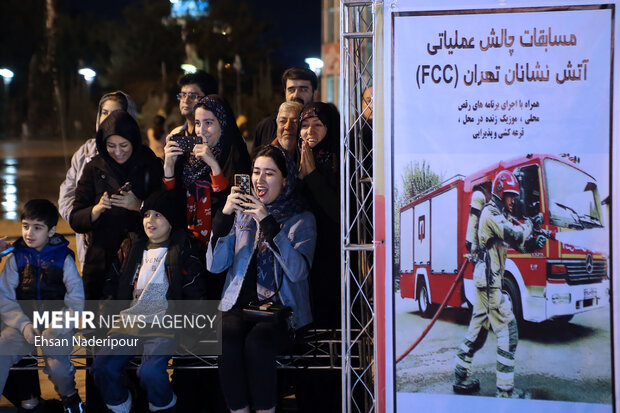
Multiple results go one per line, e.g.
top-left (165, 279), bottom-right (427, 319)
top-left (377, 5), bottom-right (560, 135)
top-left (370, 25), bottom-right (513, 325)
top-left (254, 145), bottom-right (306, 300)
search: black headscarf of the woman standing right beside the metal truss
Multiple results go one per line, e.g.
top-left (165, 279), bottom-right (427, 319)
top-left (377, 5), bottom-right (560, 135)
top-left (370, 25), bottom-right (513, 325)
top-left (299, 102), bottom-right (340, 175)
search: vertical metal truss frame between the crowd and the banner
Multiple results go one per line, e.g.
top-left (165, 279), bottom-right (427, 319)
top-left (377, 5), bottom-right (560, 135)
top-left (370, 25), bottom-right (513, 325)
top-left (339, 0), bottom-right (382, 413)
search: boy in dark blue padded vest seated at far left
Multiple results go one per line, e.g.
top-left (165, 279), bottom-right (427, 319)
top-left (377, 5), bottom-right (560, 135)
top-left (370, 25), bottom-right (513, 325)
top-left (0, 199), bottom-right (84, 413)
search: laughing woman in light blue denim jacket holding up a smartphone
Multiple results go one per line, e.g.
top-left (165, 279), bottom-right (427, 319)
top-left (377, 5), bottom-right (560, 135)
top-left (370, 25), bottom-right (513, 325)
top-left (207, 146), bottom-right (316, 413)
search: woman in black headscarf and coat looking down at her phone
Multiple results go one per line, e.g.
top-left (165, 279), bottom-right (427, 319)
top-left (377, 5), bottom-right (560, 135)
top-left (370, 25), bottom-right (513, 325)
top-left (69, 110), bottom-right (162, 300)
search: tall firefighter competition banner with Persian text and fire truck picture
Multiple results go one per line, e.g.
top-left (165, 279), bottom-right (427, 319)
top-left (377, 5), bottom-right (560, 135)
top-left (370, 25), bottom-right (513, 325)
top-left (383, 1), bottom-right (618, 412)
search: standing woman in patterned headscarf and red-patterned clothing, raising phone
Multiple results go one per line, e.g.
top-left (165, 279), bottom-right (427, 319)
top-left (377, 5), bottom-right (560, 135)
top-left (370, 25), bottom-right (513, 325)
top-left (164, 95), bottom-right (250, 249)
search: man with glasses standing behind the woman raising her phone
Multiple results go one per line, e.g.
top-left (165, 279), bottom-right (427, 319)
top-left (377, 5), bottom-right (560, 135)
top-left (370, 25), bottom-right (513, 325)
top-left (170, 70), bottom-right (217, 135)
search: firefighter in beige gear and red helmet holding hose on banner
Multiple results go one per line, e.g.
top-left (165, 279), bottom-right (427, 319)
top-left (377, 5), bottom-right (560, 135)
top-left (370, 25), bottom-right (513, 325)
top-left (452, 170), bottom-right (546, 398)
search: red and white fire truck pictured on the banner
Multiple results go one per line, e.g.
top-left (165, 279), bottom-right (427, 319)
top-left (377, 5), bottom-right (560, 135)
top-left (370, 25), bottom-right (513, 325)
top-left (400, 154), bottom-right (610, 322)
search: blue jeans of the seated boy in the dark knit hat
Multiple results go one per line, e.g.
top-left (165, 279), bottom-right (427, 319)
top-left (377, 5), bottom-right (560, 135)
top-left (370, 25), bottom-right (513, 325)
top-left (91, 334), bottom-right (175, 407)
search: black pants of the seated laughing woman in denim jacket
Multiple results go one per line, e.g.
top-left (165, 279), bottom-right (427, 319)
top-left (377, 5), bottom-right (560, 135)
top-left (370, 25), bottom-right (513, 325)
top-left (219, 308), bottom-right (290, 410)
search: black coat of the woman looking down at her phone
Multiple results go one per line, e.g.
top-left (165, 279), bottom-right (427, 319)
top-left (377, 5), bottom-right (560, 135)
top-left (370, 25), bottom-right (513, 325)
top-left (69, 146), bottom-right (163, 299)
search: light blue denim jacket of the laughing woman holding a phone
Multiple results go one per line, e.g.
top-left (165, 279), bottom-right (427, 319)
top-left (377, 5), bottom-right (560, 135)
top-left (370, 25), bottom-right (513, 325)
top-left (207, 211), bottom-right (316, 330)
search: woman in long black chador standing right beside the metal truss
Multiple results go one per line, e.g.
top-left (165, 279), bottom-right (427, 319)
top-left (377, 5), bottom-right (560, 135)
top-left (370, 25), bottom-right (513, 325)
top-left (294, 102), bottom-right (341, 413)
